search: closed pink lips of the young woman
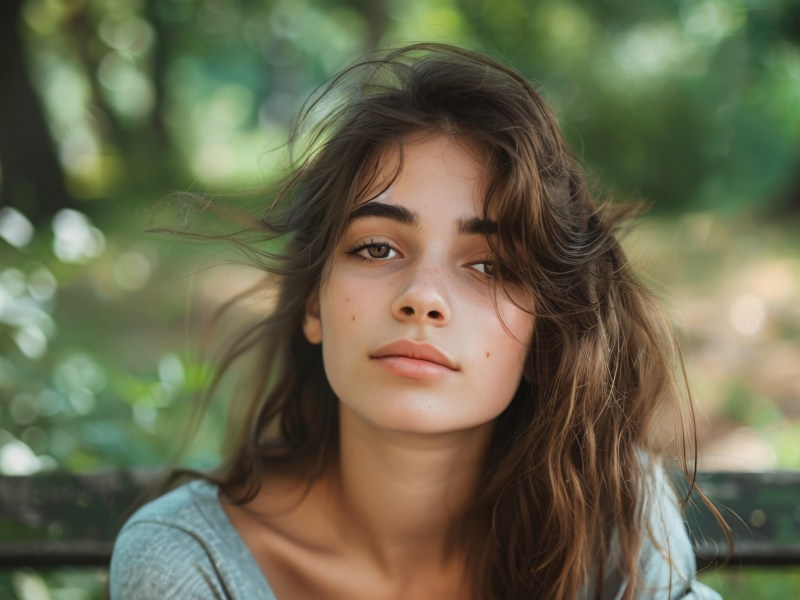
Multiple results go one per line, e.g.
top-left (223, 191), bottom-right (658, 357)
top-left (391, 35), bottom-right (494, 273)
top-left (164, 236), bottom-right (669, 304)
top-left (370, 340), bottom-right (459, 379)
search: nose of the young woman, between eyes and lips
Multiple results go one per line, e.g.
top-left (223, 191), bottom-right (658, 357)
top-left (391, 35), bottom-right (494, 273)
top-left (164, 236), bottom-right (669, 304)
top-left (392, 267), bottom-right (452, 326)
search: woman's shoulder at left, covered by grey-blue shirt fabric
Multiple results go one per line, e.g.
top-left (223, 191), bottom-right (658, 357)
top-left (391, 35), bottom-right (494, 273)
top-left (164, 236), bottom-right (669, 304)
top-left (109, 480), bottom-right (274, 600)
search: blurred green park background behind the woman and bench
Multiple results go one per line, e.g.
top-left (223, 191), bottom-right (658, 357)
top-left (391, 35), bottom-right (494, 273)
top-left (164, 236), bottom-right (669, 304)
top-left (0, 0), bottom-right (800, 599)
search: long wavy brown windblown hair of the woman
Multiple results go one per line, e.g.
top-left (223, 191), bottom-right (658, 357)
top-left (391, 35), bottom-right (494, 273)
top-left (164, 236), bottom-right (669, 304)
top-left (177, 44), bottom-right (724, 598)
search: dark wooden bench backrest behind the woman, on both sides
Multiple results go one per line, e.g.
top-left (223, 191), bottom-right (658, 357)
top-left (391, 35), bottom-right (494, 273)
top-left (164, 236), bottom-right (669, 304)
top-left (0, 471), bottom-right (800, 569)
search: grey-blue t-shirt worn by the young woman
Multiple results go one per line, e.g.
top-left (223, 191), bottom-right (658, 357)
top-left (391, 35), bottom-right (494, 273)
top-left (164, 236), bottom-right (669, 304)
top-left (110, 474), bottom-right (719, 600)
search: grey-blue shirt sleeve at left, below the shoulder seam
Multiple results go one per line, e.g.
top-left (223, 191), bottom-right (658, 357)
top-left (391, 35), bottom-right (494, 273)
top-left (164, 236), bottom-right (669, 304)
top-left (109, 521), bottom-right (228, 600)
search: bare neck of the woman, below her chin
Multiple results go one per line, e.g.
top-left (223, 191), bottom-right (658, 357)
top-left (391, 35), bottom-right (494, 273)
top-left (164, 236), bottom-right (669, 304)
top-left (331, 406), bottom-right (491, 574)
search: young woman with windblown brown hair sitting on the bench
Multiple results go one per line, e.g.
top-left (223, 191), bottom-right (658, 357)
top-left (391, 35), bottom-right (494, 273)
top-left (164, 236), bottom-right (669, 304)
top-left (110, 45), bottom-right (717, 600)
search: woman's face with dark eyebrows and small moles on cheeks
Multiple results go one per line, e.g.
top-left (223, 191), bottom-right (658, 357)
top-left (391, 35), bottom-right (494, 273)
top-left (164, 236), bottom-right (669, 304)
top-left (304, 135), bottom-right (534, 433)
